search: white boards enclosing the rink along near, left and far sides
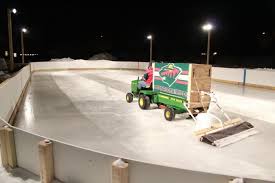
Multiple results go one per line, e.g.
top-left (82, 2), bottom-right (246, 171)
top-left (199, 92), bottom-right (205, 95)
top-left (0, 60), bottom-right (275, 183)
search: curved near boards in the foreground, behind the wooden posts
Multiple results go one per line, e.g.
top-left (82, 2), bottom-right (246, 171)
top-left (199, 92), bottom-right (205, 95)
top-left (10, 129), bottom-right (272, 183)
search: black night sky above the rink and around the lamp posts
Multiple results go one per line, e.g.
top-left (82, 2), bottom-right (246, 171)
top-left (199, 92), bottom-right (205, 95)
top-left (0, 0), bottom-right (275, 65)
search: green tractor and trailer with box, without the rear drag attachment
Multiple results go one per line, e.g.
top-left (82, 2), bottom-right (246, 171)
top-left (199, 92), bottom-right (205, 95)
top-left (126, 63), bottom-right (211, 121)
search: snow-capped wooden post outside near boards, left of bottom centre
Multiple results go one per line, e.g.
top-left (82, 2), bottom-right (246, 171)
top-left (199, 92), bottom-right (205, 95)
top-left (112, 159), bottom-right (129, 183)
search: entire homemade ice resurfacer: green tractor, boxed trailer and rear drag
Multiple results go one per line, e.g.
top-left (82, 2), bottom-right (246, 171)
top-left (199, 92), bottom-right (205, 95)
top-left (126, 62), bottom-right (258, 147)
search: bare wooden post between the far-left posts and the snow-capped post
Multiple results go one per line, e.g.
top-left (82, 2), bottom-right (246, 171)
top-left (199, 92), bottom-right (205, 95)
top-left (38, 140), bottom-right (54, 183)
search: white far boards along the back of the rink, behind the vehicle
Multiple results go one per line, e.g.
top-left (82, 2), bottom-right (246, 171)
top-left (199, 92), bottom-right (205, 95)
top-left (31, 60), bottom-right (275, 87)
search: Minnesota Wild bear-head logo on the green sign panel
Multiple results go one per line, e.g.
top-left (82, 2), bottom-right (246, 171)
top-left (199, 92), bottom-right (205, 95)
top-left (159, 63), bottom-right (182, 87)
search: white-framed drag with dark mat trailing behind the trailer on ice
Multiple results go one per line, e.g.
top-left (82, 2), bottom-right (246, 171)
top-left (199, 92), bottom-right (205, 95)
top-left (185, 92), bottom-right (259, 147)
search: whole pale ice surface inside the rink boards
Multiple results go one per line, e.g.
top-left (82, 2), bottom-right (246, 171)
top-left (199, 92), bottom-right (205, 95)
top-left (15, 70), bottom-right (275, 181)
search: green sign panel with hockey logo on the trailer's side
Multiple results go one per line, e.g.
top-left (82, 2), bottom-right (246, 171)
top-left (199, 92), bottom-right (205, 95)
top-left (154, 63), bottom-right (189, 98)
